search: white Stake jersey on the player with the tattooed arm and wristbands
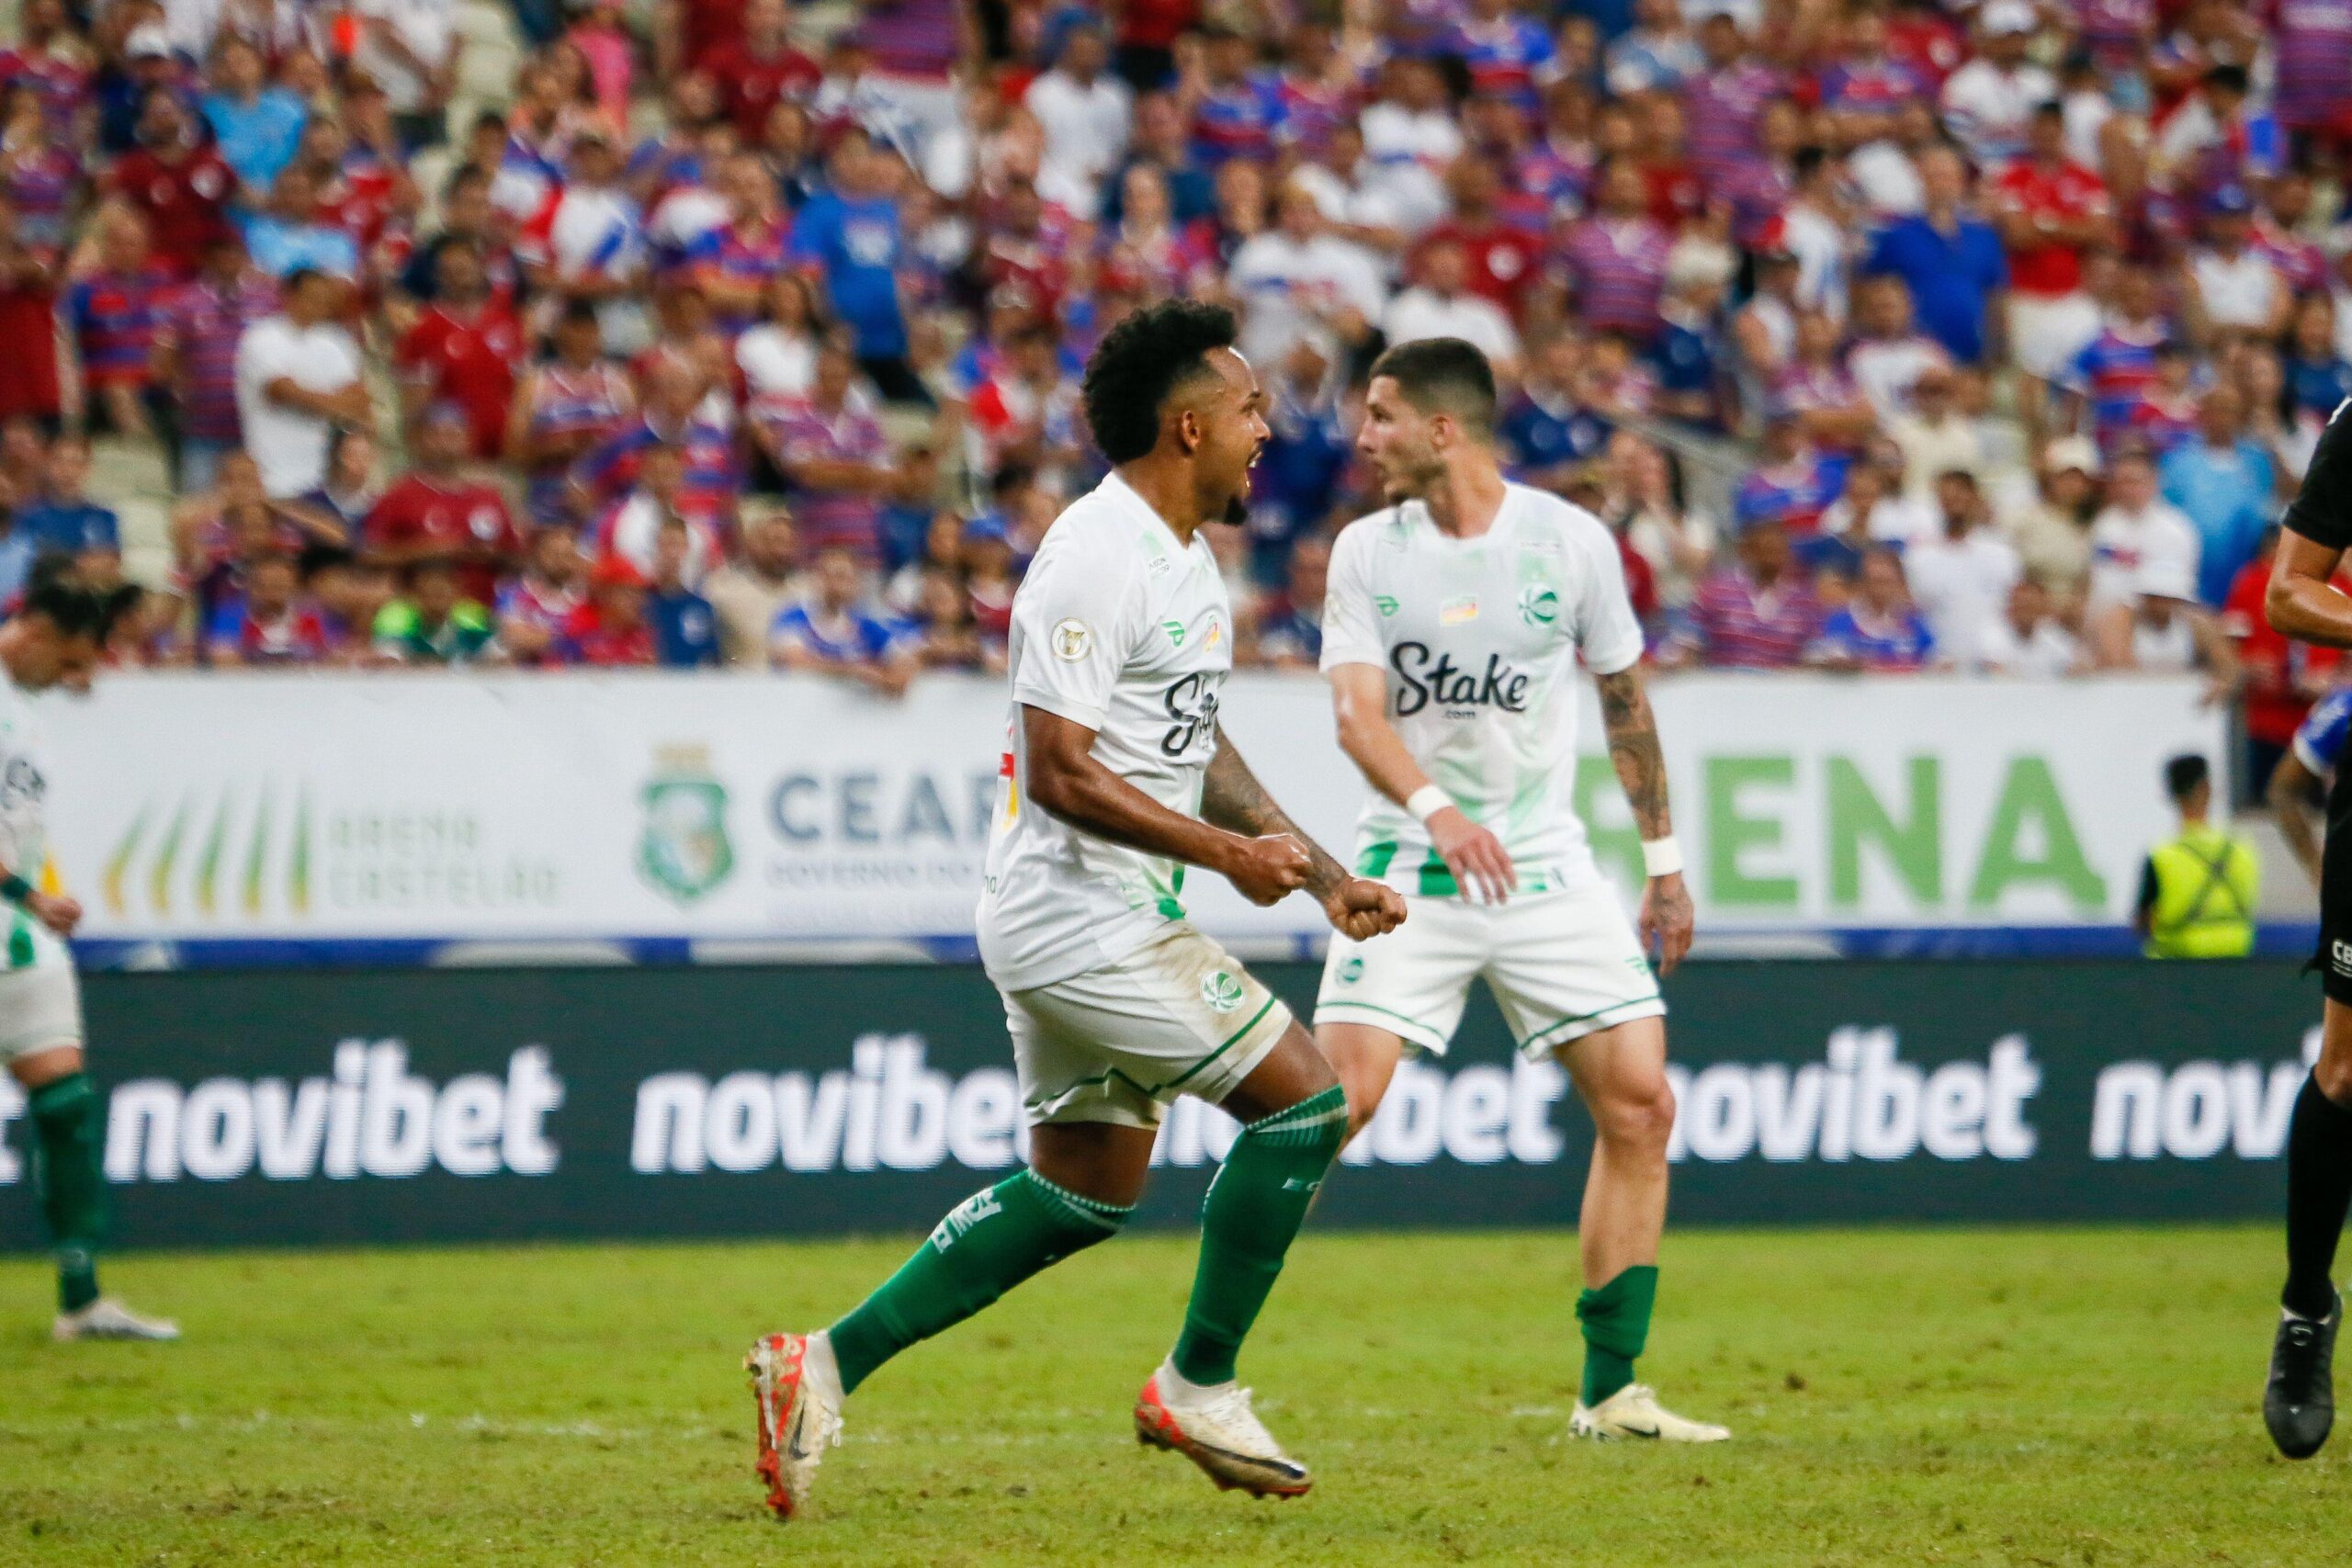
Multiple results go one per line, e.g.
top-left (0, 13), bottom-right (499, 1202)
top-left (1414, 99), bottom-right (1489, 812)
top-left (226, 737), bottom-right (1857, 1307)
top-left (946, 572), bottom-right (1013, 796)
top-left (1322, 484), bottom-right (1642, 898)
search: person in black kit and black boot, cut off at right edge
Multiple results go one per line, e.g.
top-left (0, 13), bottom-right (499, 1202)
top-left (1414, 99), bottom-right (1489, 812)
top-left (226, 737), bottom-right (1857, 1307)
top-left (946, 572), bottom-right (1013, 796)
top-left (2263, 398), bottom-right (2352, 1460)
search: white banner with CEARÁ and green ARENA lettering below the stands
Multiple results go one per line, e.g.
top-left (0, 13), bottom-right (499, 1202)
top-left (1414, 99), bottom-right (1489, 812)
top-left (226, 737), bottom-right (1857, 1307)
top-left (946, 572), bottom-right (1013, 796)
top-left (47, 674), bottom-right (2222, 952)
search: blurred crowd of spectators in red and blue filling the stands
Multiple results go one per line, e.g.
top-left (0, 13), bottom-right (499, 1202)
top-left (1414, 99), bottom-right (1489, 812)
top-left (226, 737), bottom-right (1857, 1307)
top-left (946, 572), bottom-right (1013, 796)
top-left (0, 0), bottom-right (2352, 761)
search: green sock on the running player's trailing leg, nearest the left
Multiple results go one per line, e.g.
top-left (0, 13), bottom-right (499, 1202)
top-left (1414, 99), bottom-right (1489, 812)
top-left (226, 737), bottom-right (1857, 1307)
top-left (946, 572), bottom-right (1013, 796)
top-left (828, 1170), bottom-right (1134, 1394)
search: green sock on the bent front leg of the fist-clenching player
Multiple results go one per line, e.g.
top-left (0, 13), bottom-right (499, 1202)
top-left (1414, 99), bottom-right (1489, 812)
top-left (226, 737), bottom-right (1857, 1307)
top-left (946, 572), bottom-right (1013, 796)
top-left (1173, 1086), bottom-right (1348, 1384)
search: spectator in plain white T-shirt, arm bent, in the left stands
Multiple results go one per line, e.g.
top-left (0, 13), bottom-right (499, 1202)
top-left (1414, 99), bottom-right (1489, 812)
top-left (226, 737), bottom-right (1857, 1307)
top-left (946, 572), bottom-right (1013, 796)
top-left (238, 268), bottom-right (369, 496)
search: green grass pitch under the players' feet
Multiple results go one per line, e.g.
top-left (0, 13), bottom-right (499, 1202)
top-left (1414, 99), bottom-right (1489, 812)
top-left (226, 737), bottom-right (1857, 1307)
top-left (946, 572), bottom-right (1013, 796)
top-left (0, 1227), bottom-right (2352, 1568)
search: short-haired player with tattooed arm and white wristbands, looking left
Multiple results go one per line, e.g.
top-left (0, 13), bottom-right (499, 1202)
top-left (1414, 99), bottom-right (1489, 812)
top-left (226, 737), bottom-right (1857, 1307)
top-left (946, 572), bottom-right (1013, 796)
top-left (1315, 339), bottom-right (1731, 1443)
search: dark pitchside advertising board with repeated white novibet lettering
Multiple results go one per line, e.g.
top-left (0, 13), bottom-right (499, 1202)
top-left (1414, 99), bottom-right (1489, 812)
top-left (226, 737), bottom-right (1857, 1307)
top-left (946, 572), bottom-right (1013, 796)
top-left (0, 962), bottom-right (2319, 1248)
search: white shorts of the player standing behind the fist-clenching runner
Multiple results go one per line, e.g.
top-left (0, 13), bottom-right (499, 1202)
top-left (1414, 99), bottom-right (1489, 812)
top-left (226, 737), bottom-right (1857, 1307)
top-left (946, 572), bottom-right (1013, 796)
top-left (1315, 886), bottom-right (1665, 1058)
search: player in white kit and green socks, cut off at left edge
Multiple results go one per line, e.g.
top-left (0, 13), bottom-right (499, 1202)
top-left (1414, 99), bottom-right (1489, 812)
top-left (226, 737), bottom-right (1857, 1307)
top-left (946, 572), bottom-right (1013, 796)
top-left (0, 571), bottom-right (179, 1340)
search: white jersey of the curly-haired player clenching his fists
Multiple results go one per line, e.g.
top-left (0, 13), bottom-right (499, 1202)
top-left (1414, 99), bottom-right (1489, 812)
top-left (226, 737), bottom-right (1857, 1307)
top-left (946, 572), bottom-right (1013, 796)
top-left (978, 475), bottom-right (1232, 992)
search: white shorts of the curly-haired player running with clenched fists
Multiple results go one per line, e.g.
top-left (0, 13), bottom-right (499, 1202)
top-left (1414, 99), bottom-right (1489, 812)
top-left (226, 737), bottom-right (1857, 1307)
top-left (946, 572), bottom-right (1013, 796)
top-left (1004, 921), bottom-right (1291, 1128)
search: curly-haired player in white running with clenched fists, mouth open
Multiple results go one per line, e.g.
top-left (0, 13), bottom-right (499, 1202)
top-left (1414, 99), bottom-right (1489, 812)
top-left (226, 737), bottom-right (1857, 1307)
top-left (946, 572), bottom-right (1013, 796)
top-left (746, 301), bottom-right (1404, 1518)
